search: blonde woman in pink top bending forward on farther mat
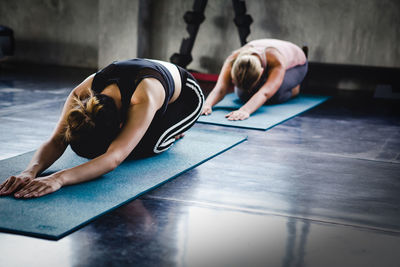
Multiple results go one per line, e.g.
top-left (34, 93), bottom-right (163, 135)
top-left (202, 39), bottom-right (308, 120)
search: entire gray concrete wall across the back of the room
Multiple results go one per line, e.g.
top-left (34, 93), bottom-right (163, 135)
top-left (0, 0), bottom-right (400, 72)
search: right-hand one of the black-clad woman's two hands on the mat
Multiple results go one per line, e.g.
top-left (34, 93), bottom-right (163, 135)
top-left (14, 175), bottom-right (62, 198)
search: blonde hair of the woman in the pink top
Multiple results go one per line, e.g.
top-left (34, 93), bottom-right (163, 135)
top-left (231, 49), bottom-right (262, 91)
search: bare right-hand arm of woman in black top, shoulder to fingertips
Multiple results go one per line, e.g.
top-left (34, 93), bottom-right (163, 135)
top-left (10, 78), bottom-right (165, 198)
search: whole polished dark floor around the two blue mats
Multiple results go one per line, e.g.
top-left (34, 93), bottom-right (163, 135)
top-left (0, 63), bottom-right (400, 267)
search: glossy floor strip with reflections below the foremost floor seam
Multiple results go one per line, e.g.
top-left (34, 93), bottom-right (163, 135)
top-left (0, 196), bottom-right (400, 267)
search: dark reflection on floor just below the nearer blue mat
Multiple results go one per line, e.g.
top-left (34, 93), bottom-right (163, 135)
top-left (70, 199), bottom-right (162, 267)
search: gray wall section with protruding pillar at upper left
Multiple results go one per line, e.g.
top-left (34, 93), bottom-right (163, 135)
top-left (0, 0), bottom-right (139, 68)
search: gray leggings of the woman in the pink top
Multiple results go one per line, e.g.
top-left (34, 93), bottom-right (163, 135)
top-left (235, 62), bottom-right (308, 104)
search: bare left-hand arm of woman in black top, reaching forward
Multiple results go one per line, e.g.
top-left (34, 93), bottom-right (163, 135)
top-left (0, 75), bottom-right (93, 196)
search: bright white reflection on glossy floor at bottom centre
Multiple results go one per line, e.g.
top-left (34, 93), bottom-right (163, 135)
top-left (176, 206), bottom-right (287, 266)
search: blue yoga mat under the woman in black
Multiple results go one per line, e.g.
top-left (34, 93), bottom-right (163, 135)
top-left (0, 128), bottom-right (246, 240)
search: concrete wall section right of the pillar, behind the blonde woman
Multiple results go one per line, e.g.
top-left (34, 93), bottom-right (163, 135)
top-left (147, 0), bottom-right (400, 72)
